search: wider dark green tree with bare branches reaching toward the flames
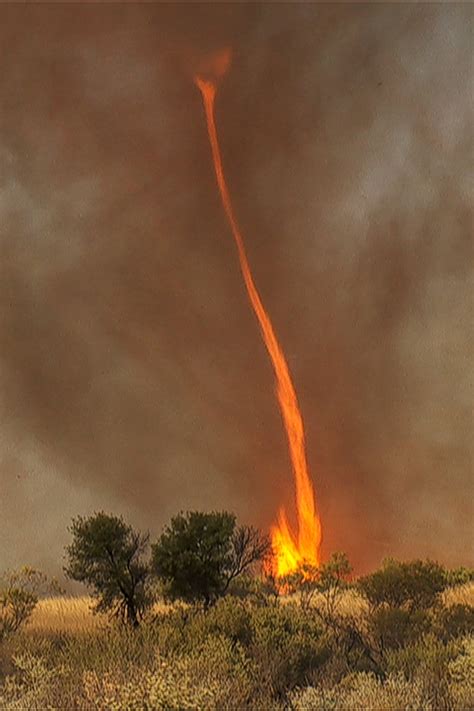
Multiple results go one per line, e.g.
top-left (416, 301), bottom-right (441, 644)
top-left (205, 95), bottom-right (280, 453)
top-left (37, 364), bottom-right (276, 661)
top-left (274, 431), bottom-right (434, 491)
top-left (152, 511), bottom-right (270, 607)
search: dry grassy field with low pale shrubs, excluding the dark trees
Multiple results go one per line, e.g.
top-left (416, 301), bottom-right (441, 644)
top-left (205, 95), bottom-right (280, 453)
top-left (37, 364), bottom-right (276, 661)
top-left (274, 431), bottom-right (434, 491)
top-left (0, 583), bottom-right (474, 711)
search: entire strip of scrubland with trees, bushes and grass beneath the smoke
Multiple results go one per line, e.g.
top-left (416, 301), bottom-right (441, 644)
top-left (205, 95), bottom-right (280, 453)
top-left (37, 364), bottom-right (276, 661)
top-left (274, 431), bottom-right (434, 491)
top-left (0, 515), bottom-right (474, 711)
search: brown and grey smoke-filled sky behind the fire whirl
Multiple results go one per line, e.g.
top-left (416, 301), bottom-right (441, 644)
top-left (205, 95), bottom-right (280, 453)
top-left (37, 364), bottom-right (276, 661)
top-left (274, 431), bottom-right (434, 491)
top-left (0, 3), bottom-right (473, 569)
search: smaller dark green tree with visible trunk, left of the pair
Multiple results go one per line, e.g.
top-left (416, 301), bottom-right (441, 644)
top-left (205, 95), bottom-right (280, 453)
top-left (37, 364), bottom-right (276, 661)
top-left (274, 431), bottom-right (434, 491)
top-left (64, 512), bottom-right (152, 627)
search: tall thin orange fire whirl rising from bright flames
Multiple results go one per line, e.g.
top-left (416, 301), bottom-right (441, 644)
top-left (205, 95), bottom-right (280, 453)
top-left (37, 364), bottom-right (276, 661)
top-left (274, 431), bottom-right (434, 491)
top-left (195, 51), bottom-right (321, 577)
